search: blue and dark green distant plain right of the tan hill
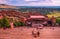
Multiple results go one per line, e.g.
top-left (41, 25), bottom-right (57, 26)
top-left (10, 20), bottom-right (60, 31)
top-left (16, 6), bottom-right (60, 14)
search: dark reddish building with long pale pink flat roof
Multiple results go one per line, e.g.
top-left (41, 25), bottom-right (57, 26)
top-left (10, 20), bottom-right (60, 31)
top-left (26, 15), bottom-right (46, 26)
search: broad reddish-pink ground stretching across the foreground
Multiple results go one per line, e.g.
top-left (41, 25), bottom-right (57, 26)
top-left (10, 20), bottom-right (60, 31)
top-left (0, 27), bottom-right (60, 39)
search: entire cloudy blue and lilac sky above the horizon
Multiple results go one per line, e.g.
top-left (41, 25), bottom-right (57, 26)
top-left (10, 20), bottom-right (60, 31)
top-left (0, 0), bottom-right (60, 6)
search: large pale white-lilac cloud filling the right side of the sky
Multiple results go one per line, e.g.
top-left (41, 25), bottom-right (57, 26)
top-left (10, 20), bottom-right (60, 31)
top-left (21, 0), bottom-right (60, 6)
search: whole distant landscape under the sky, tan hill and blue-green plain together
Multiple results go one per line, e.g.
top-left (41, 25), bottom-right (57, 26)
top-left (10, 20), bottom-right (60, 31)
top-left (0, 4), bottom-right (60, 15)
